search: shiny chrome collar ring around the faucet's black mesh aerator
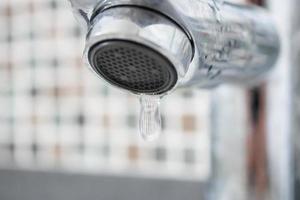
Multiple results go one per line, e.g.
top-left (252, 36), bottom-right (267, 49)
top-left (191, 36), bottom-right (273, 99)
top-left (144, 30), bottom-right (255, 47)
top-left (84, 7), bottom-right (193, 94)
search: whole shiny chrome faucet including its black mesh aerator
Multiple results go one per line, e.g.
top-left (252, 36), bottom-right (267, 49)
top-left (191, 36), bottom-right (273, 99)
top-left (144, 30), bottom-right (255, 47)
top-left (70, 0), bottom-right (280, 96)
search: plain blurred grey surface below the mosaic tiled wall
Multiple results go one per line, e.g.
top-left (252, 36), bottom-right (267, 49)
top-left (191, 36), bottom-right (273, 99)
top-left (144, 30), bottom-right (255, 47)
top-left (0, 170), bottom-right (204, 200)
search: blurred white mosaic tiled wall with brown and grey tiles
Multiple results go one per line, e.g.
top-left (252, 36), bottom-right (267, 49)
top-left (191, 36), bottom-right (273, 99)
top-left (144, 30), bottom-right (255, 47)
top-left (0, 0), bottom-right (211, 180)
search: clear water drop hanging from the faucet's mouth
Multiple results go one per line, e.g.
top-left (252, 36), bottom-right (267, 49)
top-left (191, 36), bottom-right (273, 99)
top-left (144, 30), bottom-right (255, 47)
top-left (139, 95), bottom-right (161, 141)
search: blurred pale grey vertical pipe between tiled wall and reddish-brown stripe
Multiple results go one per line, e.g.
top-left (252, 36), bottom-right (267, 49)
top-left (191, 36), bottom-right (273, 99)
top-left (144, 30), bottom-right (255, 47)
top-left (210, 85), bottom-right (249, 200)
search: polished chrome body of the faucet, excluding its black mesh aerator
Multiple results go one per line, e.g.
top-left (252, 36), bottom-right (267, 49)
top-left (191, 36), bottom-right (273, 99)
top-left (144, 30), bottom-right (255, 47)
top-left (70, 0), bottom-right (280, 93)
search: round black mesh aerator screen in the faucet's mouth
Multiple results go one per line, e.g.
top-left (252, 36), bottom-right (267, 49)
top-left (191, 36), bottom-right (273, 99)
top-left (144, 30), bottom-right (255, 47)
top-left (89, 40), bottom-right (177, 94)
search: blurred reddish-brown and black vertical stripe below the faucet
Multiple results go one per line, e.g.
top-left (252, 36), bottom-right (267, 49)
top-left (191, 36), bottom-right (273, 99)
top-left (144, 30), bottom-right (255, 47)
top-left (247, 0), bottom-right (270, 200)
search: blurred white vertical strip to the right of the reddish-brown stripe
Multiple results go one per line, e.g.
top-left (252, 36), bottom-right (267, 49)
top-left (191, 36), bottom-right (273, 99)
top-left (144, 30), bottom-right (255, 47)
top-left (266, 0), bottom-right (299, 200)
